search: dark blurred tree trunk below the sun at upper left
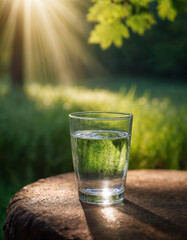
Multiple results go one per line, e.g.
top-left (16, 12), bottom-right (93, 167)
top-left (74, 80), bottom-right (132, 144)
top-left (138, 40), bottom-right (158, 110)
top-left (11, 2), bottom-right (24, 88)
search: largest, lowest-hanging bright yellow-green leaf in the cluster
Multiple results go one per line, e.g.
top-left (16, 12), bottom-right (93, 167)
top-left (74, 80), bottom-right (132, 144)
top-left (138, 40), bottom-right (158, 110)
top-left (89, 21), bottom-right (129, 49)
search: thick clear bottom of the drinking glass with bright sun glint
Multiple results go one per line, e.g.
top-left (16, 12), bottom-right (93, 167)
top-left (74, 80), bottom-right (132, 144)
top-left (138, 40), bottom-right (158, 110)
top-left (79, 189), bottom-right (124, 206)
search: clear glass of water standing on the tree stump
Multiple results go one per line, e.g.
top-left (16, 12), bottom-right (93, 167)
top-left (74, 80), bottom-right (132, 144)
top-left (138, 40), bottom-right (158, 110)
top-left (69, 112), bottom-right (133, 205)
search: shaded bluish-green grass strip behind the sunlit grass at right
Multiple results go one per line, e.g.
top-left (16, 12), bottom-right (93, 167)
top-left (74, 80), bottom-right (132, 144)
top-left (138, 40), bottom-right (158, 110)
top-left (82, 76), bottom-right (187, 105)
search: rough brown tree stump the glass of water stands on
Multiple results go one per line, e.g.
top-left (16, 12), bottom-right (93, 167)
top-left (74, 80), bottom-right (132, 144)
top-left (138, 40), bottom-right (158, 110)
top-left (3, 170), bottom-right (187, 240)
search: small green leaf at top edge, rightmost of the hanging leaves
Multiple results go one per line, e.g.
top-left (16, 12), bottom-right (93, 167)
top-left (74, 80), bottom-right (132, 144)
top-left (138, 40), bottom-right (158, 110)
top-left (157, 0), bottom-right (177, 21)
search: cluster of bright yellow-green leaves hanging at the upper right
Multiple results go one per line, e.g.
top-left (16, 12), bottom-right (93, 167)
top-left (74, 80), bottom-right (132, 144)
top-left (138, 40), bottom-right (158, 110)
top-left (87, 0), bottom-right (186, 49)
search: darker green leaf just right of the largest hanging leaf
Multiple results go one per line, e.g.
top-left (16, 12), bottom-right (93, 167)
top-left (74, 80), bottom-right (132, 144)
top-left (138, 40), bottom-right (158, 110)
top-left (126, 13), bottom-right (156, 35)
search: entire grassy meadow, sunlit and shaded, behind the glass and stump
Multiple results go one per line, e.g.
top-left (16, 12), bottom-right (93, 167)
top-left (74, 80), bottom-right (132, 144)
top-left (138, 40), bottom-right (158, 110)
top-left (0, 78), bottom-right (187, 237)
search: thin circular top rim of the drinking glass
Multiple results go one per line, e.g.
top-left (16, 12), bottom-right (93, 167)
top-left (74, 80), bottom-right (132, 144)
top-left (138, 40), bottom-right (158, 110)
top-left (69, 111), bottom-right (133, 120)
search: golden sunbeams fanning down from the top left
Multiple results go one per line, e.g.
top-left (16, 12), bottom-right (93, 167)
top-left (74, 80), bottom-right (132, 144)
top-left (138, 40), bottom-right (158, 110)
top-left (0, 0), bottom-right (101, 81)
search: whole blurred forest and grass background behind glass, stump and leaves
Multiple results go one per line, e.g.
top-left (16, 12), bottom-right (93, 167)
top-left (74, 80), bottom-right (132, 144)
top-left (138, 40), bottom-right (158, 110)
top-left (0, 0), bottom-right (187, 237)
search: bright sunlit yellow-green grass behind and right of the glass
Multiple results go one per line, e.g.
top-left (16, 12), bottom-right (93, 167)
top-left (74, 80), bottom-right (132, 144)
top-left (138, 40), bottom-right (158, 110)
top-left (26, 84), bottom-right (187, 169)
